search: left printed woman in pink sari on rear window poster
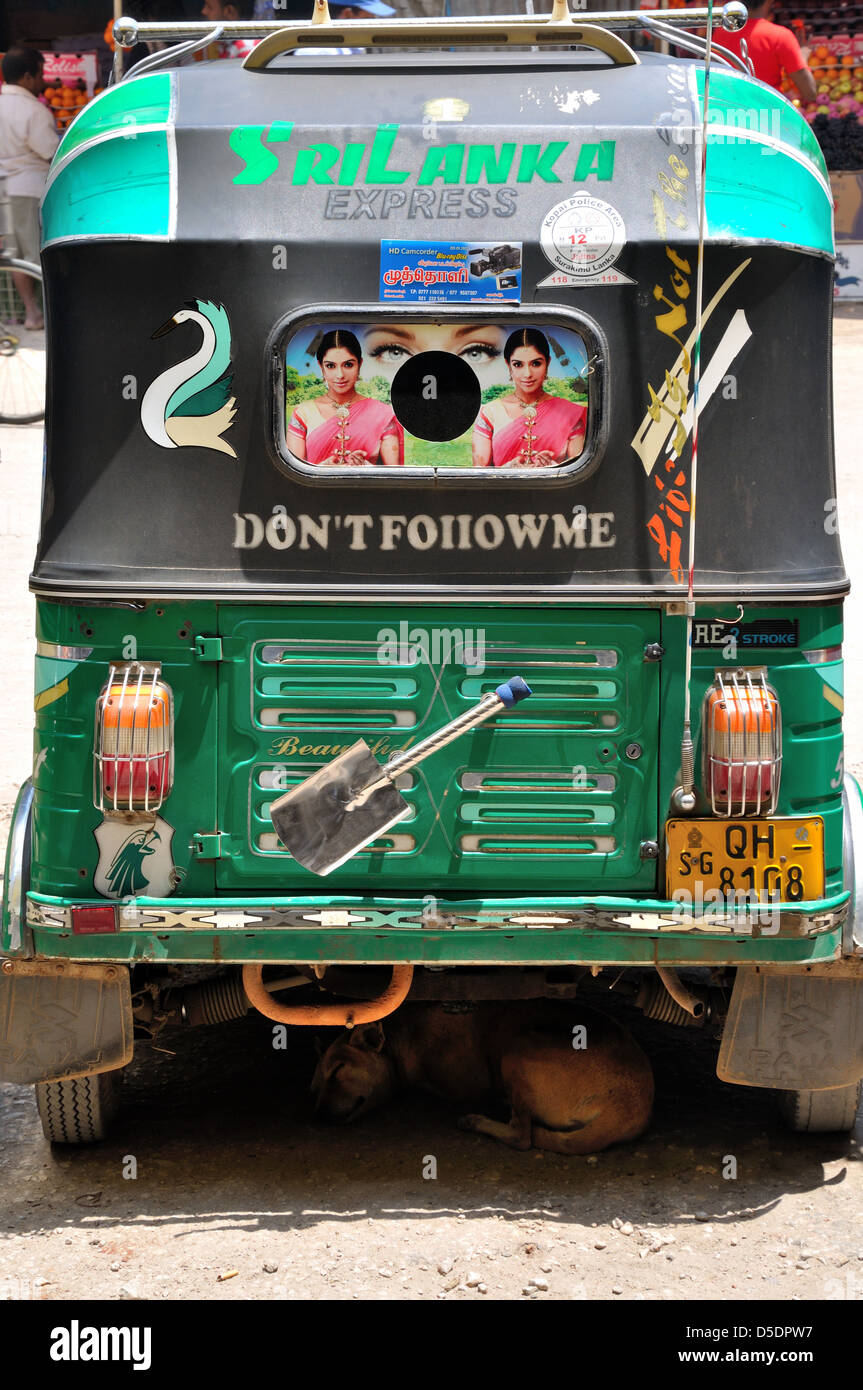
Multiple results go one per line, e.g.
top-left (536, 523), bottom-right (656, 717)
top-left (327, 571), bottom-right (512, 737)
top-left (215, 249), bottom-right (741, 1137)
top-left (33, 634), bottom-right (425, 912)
top-left (288, 328), bottom-right (404, 468)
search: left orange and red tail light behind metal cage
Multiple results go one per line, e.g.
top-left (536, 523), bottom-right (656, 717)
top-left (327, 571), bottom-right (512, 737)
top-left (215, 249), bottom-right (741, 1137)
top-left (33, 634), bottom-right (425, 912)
top-left (93, 662), bottom-right (174, 810)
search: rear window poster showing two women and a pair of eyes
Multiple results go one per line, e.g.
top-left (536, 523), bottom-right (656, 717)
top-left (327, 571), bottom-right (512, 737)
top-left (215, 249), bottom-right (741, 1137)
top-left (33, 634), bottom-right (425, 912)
top-left (285, 318), bottom-right (589, 470)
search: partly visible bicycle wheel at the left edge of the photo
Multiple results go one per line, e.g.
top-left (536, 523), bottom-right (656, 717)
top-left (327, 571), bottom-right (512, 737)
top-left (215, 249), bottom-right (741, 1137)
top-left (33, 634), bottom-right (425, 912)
top-left (0, 260), bottom-right (44, 425)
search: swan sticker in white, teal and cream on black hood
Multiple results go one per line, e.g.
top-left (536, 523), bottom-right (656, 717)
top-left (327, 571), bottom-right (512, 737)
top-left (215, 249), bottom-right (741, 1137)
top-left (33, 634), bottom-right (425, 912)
top-left (140, 299), bottom-right (236, 459)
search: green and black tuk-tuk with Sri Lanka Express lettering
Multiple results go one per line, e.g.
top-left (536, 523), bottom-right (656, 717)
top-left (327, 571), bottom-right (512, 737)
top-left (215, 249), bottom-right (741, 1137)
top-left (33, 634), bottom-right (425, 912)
top-left (0, 4), bottom-right (863, 1141)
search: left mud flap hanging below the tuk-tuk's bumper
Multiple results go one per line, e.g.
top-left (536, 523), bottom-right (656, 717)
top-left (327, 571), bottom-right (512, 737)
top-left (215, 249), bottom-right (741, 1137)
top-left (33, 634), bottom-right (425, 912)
top-left (0, 960), bottom-right (132, 1084)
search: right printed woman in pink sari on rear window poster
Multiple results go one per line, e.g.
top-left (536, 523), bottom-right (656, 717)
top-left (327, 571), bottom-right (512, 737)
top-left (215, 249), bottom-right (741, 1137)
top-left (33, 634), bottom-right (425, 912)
top-left (472, 328), bottom-right (588, 468)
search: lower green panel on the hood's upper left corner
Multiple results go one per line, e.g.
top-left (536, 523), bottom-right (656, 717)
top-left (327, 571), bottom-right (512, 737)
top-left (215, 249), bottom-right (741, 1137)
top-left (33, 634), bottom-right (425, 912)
top-left (42, 131), bottom-right (171, 246)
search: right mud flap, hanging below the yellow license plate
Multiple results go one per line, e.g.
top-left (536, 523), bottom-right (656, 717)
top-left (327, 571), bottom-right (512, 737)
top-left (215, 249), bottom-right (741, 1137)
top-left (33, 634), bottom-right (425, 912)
top-left (716, 963), bottom-right (863, 1091)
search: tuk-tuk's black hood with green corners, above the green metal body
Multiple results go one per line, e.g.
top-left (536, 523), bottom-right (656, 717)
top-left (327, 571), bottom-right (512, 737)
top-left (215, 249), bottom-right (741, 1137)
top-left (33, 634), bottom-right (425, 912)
top-left (33, 36), bottom-right (846, 603)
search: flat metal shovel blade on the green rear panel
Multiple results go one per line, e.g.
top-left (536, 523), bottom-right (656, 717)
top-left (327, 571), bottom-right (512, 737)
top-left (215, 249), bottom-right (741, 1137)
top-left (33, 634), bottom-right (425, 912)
top-left (271, 738), bottom-right (410, 877)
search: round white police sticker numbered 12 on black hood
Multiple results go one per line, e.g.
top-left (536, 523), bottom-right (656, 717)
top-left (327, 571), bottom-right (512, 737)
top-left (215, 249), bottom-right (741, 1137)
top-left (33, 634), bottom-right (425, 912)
top-left (536, 193), bottom-right (634, 289)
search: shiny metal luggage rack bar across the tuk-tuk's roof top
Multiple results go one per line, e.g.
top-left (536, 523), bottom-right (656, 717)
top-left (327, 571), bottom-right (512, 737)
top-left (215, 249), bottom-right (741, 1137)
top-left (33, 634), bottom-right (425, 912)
top-left (114, 0), bottom-right (748, 71)
